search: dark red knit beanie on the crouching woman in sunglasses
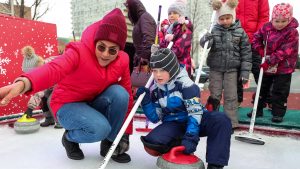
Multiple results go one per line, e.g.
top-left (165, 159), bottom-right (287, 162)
top-left (94, 8), bottom-right (127, 50)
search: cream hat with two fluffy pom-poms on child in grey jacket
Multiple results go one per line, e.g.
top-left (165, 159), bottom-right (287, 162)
top-left (212, 0), bottom-right (238, 23)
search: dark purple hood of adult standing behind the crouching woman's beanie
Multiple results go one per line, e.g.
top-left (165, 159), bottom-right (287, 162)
top-left (126, 0), bottom-right (146, 24)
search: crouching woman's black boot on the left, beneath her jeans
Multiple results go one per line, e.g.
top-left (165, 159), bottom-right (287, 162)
top-left (62, 131), bottom-right (84, 160)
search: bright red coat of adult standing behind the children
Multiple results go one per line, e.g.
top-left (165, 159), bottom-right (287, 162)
top-left (236, 0), bottom-right (270, 43)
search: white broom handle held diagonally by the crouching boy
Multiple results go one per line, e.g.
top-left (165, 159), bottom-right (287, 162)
top-left (99, 41), bottom-right (173, 169)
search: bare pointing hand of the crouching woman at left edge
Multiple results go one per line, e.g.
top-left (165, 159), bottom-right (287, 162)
top-left (0, 81), bottom-right (25, 106)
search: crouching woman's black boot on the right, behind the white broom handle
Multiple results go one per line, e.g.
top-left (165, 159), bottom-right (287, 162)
top-left (100, 136), bottom-right (131, 163)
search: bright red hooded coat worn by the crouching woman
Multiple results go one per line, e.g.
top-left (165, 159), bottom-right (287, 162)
top-left (22, 20), bottom-right (133, 134)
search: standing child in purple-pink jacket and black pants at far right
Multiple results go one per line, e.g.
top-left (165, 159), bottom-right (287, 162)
top-left (248, 3), bottom-right (299, 123)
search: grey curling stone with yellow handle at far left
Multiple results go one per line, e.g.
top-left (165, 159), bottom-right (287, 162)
top-left (14, 114), bottom-right (40, 134)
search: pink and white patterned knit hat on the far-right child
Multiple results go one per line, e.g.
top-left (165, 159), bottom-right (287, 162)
top-left (272, 3), bottom-right (293, 22)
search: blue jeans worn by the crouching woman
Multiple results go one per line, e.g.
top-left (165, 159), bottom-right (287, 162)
top-left (57, 85), bottom-right (129, 143)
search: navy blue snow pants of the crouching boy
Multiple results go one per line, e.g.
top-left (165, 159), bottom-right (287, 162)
top-left (144, 111), bottom-right (231, 166)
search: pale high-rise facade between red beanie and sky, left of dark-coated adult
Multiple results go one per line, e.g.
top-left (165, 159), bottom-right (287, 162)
top-left (71, 0), bottom-right (125, 36)
